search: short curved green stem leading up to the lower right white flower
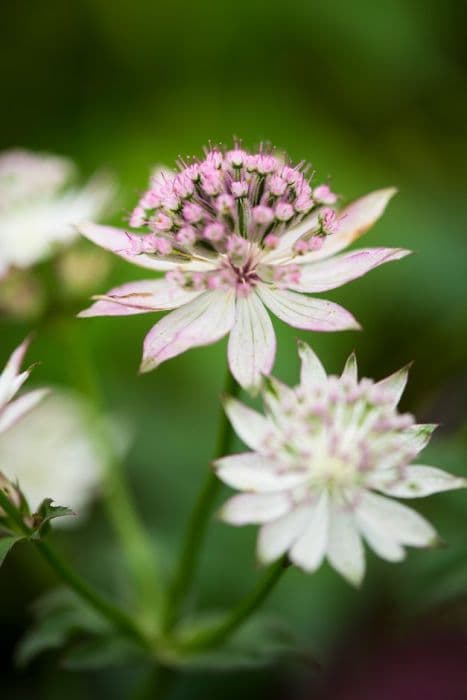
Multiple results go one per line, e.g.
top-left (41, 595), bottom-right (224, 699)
top-left (182, 557), bottom-right (288, 651)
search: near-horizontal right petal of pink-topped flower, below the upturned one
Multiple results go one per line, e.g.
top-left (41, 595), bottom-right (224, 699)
top-left (285, 248), bottom-right (410, 292)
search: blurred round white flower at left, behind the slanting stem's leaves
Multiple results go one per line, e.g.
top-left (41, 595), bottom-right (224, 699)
top-left (0, 390), bottom-right (105, 526)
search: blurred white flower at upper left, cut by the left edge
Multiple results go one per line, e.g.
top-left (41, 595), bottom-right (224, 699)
top-left (0, 150), bottom-right (114, 277)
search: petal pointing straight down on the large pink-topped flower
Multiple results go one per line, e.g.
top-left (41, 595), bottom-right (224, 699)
top-left (228, 293), bottom-right (276, 391)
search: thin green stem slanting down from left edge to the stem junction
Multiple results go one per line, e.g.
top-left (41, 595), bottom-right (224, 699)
top-left (0, 489), bottom-right (148, 647)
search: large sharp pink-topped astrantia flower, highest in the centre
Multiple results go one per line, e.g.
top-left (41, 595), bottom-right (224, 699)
top-left (80, 148), bottom-right (408, 388)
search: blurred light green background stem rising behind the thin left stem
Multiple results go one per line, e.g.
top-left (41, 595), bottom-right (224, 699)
top-left (55, 319), bottom-right (163, 632)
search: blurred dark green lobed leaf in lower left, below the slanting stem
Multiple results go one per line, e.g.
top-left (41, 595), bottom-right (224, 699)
top-left (15, 589), bottom-right (109, 666)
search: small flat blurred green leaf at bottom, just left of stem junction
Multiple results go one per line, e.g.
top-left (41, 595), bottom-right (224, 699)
top-left (62, 634), bottom-right (147, 671)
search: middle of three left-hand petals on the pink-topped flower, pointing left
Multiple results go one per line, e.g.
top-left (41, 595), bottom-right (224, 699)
top-left (78, 279), bottom-right (201, 318)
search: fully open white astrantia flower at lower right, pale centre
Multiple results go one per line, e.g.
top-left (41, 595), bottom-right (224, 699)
top-left (215, 344), bottom-right (467, 584)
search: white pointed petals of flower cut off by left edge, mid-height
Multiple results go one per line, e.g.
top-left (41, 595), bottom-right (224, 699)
top-left (0, 339), bottom-right (47, 433)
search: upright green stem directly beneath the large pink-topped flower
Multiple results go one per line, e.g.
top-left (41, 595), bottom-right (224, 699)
top-left (165, 369), bottom-right (240, 631)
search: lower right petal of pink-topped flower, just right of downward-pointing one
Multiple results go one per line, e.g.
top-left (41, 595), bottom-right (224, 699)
top-left (257, 284), bottom-right (360, 332)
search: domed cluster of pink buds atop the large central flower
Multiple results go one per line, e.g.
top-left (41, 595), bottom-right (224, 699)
top-left (129, 145), bottom-right (337, 254)
